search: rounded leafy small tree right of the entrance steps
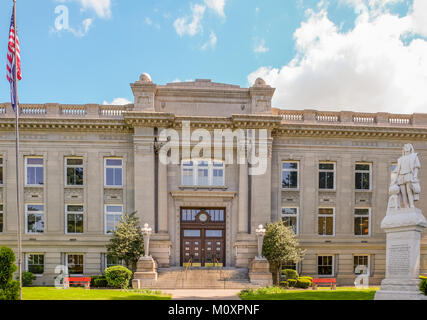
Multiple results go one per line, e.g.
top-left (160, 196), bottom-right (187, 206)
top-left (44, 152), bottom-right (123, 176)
top-left (262, 221), bottom-right (305, 285)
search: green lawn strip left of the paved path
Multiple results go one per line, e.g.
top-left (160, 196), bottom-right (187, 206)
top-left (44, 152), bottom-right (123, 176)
top-left (22, 287), bottom-right (171, 300)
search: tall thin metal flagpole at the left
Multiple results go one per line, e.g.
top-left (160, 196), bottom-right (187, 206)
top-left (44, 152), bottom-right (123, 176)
top-left (13, 0), bottom-right (22, 300)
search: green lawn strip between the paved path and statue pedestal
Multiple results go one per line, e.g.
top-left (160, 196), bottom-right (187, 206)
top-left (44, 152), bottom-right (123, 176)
top-left (239, 287), bottom-right (379, 300)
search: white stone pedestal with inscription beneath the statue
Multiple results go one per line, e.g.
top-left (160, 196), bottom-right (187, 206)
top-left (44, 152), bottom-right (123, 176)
top-left (375, 208), bottom-right (427, 300)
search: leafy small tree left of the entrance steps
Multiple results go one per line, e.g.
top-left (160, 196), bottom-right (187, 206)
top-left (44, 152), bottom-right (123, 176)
top-left (107, 212), bottom-right (144, 272)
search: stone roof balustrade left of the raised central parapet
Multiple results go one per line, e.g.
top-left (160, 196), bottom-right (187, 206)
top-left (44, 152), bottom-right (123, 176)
top-left (0, 103), bottom-right (133, 119)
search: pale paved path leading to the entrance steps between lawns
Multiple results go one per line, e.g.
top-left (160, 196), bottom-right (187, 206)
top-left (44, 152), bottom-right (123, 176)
top-left (162, 289), bottom-right (241, 300)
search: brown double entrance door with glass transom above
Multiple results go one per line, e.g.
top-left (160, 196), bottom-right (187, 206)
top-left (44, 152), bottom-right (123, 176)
top-left (181, 209), bottom-right (225, 267)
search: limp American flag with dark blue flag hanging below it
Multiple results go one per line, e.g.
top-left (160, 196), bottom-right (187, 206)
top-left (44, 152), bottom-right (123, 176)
top-left (6, 5), bottom-right (22, 110)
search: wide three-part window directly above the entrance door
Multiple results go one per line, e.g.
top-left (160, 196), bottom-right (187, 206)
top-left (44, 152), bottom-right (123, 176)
top-left (181, 160), bottom-right (225, 186)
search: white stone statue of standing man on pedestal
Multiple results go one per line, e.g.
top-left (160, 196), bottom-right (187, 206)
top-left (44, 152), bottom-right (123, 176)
top-left (396, 144), bottom-right (421, 208)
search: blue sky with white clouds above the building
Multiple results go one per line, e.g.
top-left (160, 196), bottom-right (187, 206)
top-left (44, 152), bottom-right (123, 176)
top-left (0, 0), bottom-right (427, 113)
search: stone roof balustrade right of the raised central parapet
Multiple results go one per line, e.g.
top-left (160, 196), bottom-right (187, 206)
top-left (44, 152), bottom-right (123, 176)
top-left (273, 108), bottom-right (427, 127)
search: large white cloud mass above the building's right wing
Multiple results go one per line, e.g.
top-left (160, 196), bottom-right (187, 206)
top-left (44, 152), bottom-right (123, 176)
top-left (248, 0), bottom-right (427, 113)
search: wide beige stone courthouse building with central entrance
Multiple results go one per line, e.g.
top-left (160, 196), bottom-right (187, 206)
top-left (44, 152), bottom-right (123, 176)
top-left (0, 74), bottom-right (427, 285)
